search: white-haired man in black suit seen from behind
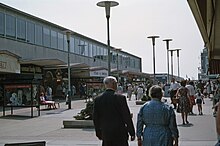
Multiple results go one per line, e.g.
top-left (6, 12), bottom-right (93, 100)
top-left (93, 76), bottom-right (135, 146)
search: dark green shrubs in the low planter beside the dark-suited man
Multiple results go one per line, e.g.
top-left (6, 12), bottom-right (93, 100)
top-left (73, 101), bottom-right (94, 120)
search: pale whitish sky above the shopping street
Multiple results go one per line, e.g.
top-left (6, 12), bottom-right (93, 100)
top-left (0, 0), bottom-right (204, 79)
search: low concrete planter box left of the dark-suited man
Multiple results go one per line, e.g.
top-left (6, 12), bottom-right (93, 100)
top-left (63, 119), bottom-right (94, 128)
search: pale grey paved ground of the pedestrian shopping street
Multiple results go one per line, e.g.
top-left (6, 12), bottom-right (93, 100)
top-left (0, 95), bottom-right (217, 146)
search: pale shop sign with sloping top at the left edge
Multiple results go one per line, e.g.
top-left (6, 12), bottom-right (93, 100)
top-left (0, 54), bottom-right (20, 73)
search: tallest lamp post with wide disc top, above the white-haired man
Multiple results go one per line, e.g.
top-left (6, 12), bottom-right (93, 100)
top-left (97, 1), bottom-right (119, 75)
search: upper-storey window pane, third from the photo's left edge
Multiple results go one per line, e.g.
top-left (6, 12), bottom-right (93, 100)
top-left (17, 18), bottom-right (26, 40)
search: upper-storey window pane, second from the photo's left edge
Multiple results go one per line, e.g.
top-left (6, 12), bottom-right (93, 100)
top-left (6, 14), bottom-right (16, 37)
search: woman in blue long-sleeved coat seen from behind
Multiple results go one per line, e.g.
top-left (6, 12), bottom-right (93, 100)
top-left (136, 85), bottom-right (179, 146)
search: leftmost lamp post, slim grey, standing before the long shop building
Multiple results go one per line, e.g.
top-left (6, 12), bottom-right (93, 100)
top-left (66, 31), bottom-right (71, 109)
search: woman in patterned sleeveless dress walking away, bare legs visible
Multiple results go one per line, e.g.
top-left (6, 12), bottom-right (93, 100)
top-left (176, 80), bottom-right (191, 125)
